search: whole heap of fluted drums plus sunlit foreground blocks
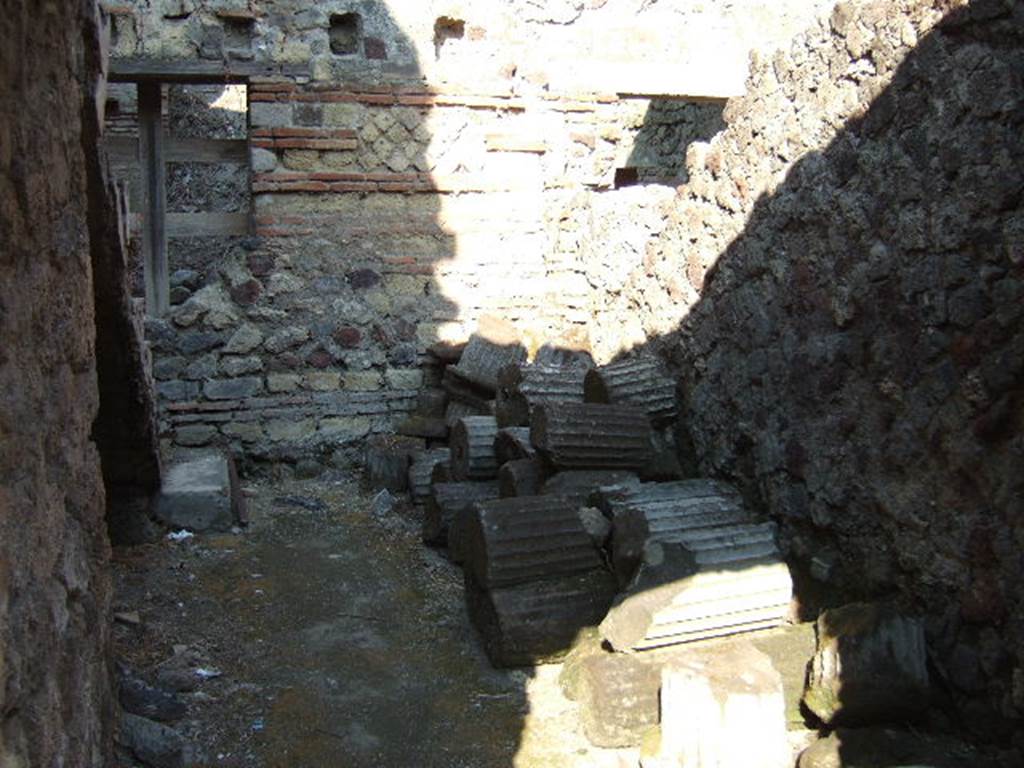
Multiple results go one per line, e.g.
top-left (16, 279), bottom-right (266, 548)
top-left (364, 321), bottom-right (995, 768)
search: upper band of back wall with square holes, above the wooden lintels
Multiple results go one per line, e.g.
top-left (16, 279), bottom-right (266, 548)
top-left (104, 0), bottom-right (835, 97)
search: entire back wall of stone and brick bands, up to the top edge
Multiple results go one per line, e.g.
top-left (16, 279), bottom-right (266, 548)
top-left (105, 0), bottom-right (830, 463)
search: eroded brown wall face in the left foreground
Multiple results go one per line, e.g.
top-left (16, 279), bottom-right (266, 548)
top-left (0, 0), bottom-right (113, 766)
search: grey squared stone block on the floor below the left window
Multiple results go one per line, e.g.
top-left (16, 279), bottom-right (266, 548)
top-left (156, 454), bottom-right (244, 531)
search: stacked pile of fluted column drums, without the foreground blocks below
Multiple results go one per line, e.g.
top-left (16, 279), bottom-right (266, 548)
top-left (387, 321), bottom-right (791, 666)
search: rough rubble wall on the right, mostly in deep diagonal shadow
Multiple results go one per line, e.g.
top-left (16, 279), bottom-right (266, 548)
top-left (598, 0), bottom-right (1024, 736)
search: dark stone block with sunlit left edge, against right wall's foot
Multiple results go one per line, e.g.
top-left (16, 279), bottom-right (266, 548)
top-left (804, 603), bottom-right (929, 724)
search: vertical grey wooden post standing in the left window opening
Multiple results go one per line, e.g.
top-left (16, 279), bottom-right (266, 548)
top-left (138, 82), bottom-right (170, 317)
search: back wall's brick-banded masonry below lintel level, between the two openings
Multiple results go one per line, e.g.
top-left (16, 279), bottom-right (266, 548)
top-left (150, 82), bottom-right (703, 468)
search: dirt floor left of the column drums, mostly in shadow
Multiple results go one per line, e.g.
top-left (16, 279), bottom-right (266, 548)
top-left (115, 477), bottom-right (636, 768)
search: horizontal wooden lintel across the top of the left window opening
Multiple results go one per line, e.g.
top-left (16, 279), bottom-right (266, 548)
top-left (110, 56), bottom-right (310, 83)
